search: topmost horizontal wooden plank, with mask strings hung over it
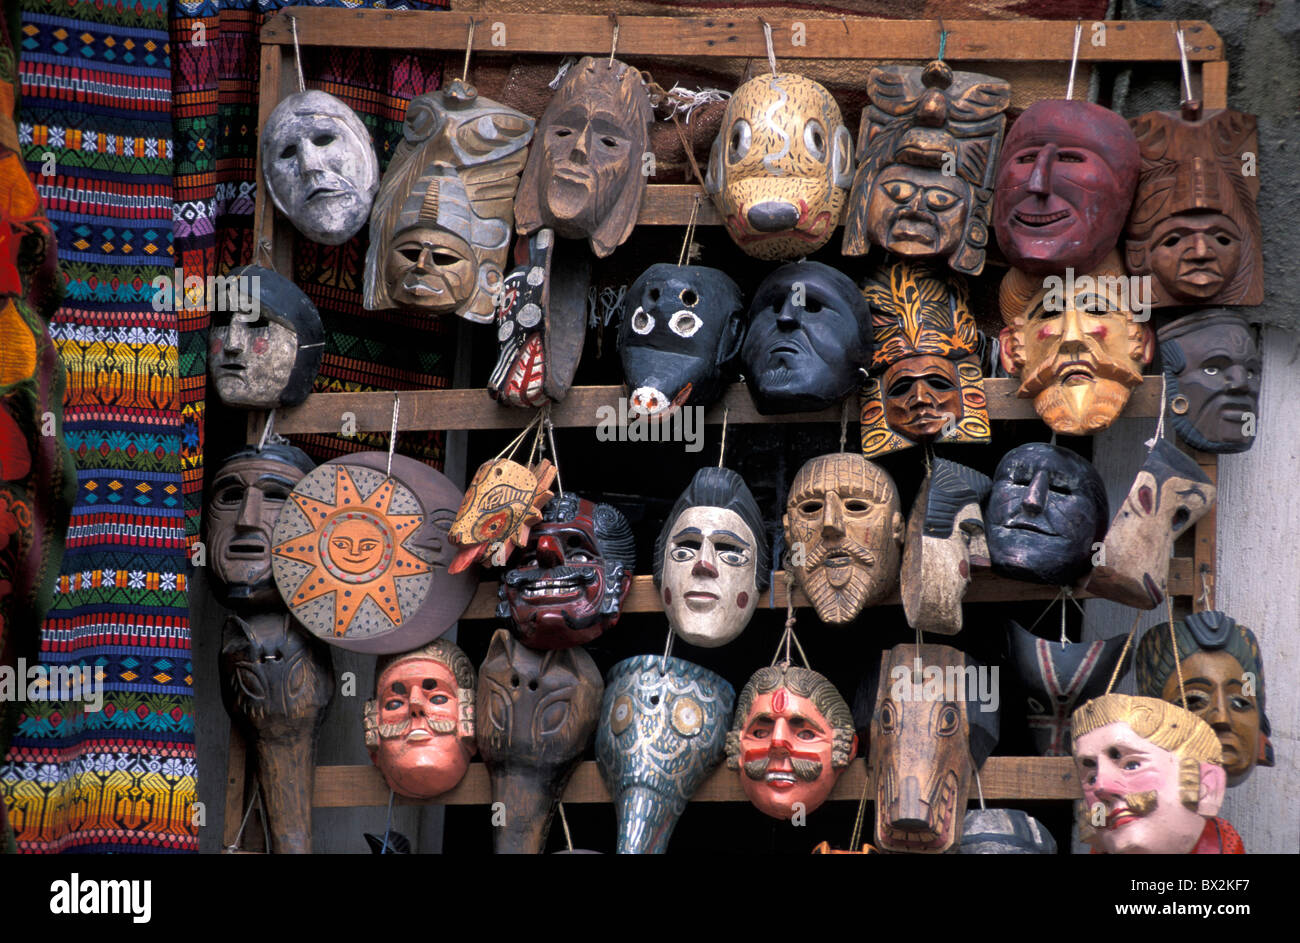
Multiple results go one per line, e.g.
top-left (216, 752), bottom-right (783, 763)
top-left (261, 8), bottom-right (1225, 62)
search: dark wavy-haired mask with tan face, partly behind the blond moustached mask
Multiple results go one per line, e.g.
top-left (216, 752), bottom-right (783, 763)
top-left (1134, 610), bottom-right (1274, 786)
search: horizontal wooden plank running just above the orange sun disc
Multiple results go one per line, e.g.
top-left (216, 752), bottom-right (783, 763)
top-left (271, 377), bottom-right (1161, 441)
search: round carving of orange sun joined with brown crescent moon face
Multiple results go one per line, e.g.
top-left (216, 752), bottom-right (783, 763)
top-left (272, 451), bottom-right (477, 654)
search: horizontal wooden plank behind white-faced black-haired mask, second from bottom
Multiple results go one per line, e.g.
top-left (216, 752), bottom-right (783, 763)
top-left (460, 557), bottom-right (1199, 622)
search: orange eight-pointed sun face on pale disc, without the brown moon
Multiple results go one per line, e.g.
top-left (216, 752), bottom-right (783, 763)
top-left (272, 464), bottom-right (433, 637)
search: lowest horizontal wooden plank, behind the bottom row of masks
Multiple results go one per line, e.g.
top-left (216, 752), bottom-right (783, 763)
top-left (312, 757), bottom-right (1082, 809)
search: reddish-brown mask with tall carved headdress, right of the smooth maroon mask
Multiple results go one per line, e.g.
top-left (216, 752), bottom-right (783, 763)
top-left (1125, 101), bottom-right (1264, 308)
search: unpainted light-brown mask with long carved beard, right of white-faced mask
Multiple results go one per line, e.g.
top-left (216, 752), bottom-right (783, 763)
top-left (781, 451), bottom-right (904, 626)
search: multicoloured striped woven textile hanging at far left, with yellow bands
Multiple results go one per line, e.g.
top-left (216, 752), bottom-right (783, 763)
top-left (0, 0), bottom-right (198, 852)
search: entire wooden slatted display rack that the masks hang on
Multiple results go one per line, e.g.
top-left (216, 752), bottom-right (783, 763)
top-left (224, 8), bottom-right (1229, 847)
